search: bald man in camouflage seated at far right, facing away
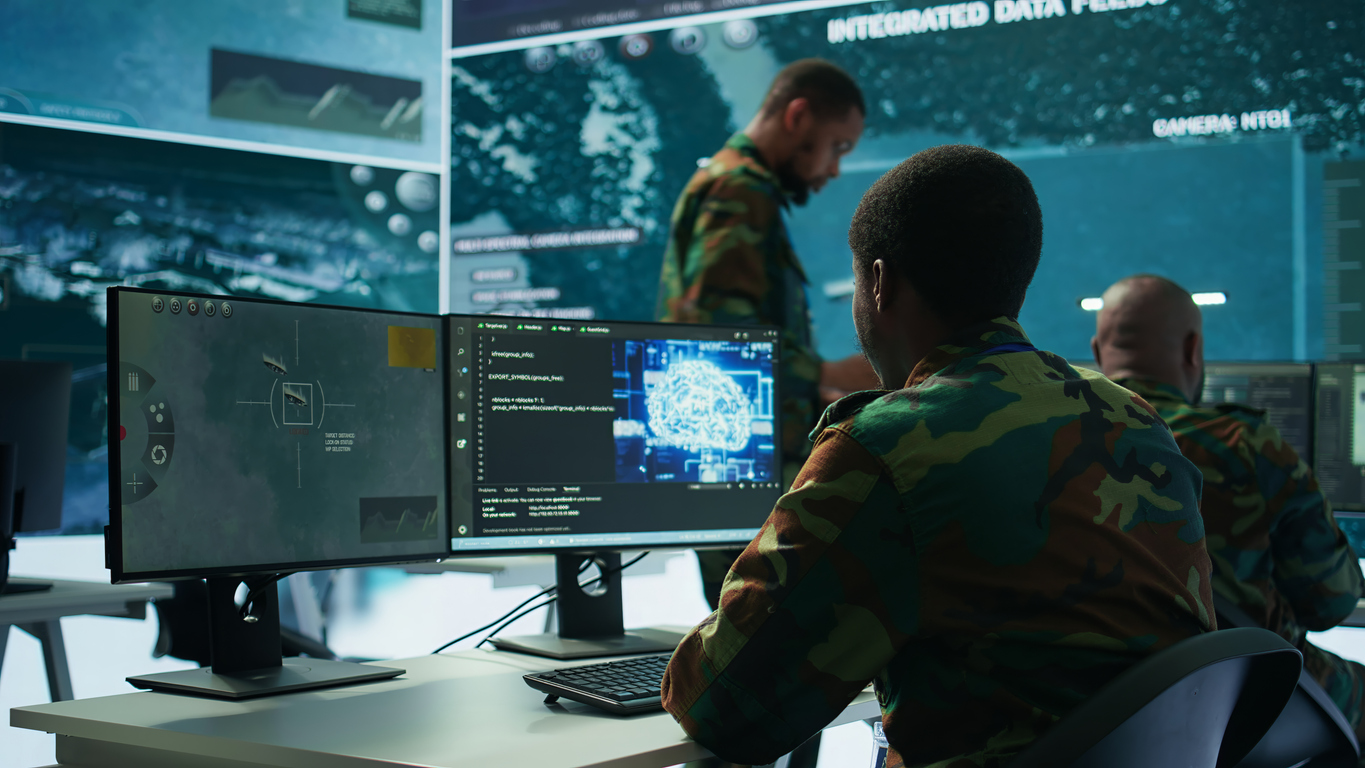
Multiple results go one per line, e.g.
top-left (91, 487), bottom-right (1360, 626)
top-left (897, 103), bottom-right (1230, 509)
top-left (1091, 274), bottom-right (1365, 741)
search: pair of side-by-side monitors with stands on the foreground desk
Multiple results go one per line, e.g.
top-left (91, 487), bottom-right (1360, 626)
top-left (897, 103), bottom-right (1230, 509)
top-left (105, 288), bottom-right (784, 697)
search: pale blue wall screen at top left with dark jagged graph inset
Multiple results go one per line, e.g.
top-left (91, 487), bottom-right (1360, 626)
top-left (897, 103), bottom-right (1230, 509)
top-left (0, 0), bottom-right (444, 164)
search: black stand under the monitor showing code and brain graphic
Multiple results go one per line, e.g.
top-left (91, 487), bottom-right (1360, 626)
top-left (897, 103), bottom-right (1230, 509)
top-left (493, 552), bottom-right (683, 660)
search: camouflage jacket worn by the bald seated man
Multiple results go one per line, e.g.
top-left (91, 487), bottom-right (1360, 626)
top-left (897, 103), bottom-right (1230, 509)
top-left (1118, 379), bottom-right (1362, 645)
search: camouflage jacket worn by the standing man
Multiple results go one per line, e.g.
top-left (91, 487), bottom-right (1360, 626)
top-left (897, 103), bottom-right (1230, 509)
top-left (655, 134), bottom-right (820, 474)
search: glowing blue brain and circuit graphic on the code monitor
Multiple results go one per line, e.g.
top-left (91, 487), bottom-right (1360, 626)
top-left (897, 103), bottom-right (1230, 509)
top-left (612, 340), bottom-right (778, 483)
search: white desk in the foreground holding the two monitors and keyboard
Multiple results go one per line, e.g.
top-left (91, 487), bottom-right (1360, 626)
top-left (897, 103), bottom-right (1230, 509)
top-left (10, 651), bottom-right (879, 768)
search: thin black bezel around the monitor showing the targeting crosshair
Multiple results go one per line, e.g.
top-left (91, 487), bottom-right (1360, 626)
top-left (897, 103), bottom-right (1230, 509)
top-left (104, 285), bottom-right (450, 584)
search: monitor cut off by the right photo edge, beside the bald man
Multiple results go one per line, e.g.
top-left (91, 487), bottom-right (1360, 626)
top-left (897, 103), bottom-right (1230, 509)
top-left (1313, 363), bottom-right (1365, 512)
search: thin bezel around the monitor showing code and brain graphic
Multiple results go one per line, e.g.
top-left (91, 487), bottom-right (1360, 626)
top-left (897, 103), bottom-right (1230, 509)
top-left (444, 312), bottom-right (790, 559)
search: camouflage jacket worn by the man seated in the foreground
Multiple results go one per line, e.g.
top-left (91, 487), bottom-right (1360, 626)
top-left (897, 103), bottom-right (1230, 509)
top-left (663, 318), bottom-right (1213, 767)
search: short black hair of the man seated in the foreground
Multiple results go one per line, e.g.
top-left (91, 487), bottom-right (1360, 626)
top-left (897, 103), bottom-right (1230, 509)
top-left (849, 145), bottom-right (1043, 325)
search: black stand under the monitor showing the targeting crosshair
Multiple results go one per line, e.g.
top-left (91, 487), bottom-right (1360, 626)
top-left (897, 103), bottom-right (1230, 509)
top-left (128, 577), bottom-right (407, 698)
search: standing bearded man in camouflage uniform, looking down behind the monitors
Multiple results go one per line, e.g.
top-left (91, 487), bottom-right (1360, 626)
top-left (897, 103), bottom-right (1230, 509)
top-left (655, 59), bottom-right (867, 638)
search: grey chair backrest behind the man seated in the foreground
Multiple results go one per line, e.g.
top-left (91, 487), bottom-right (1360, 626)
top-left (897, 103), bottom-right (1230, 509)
top-left (1010, 629), bottom-right (1302, 768)
